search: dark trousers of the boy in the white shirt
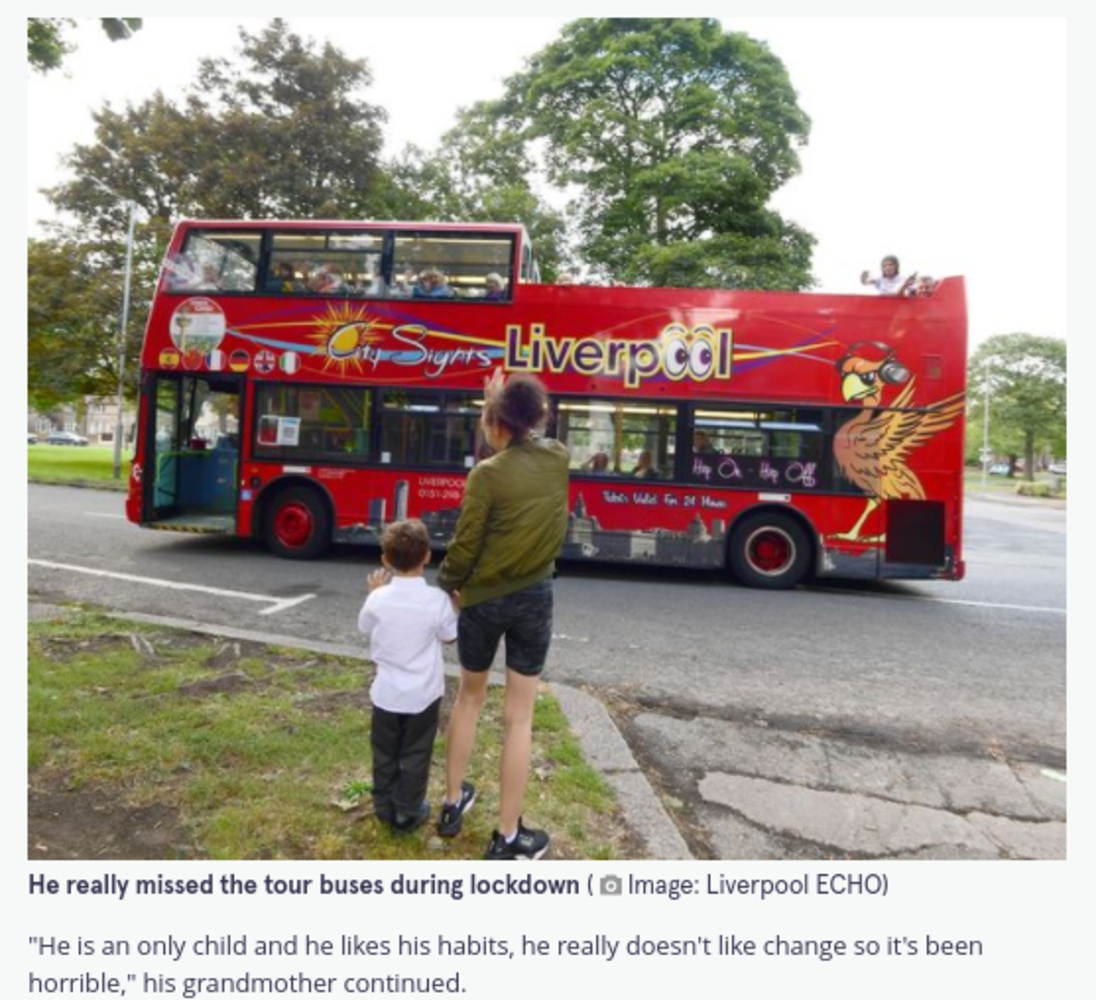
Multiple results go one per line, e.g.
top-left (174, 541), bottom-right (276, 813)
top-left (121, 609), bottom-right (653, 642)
top-left (372, 698), bottom-right (442, 822)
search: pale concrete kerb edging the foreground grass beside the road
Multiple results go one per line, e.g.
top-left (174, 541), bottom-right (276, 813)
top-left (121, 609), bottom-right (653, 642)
top-left (34, 602), bottom-right (693, 861)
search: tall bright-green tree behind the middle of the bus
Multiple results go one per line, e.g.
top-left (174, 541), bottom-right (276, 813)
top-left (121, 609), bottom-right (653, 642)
top-left (483, 18), bottom-right (814, 288)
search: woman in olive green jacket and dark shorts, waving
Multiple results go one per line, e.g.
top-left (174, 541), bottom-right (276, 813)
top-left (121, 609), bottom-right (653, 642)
top-left (437, 372), bottom-right (570, 861)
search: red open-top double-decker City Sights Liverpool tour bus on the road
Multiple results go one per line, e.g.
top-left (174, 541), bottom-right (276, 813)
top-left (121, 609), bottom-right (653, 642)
top-left (126, 221), bottom-right (967, 588)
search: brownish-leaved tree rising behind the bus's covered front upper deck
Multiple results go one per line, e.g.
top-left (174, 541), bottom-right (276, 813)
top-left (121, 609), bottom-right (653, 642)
top-left (48, 19), bottom-right (385, 224)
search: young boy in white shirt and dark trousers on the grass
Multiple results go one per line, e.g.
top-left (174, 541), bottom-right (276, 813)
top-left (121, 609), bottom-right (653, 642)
top-left (357, 520), bottom-right (457, 833)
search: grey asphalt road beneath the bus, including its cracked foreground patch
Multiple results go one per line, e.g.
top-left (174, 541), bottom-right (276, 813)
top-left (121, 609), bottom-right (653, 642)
top-left (30, 487), bottom-right (1065, 857)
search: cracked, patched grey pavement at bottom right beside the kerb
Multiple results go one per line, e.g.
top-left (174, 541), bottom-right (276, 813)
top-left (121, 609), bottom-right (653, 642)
top-left (614, 708), bottom-right (1065, 860)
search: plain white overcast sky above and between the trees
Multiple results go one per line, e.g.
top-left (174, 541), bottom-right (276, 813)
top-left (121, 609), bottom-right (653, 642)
top-left (27, 16), bottom-right (1066, 346)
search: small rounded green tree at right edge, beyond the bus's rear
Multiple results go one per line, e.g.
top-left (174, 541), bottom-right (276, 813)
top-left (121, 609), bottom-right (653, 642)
top-left (968, 333), bottom-right (1065, 480)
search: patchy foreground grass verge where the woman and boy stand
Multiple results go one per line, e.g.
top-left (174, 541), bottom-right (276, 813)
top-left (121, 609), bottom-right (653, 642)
top-left (27, 613), bottom-right (642, 861)
